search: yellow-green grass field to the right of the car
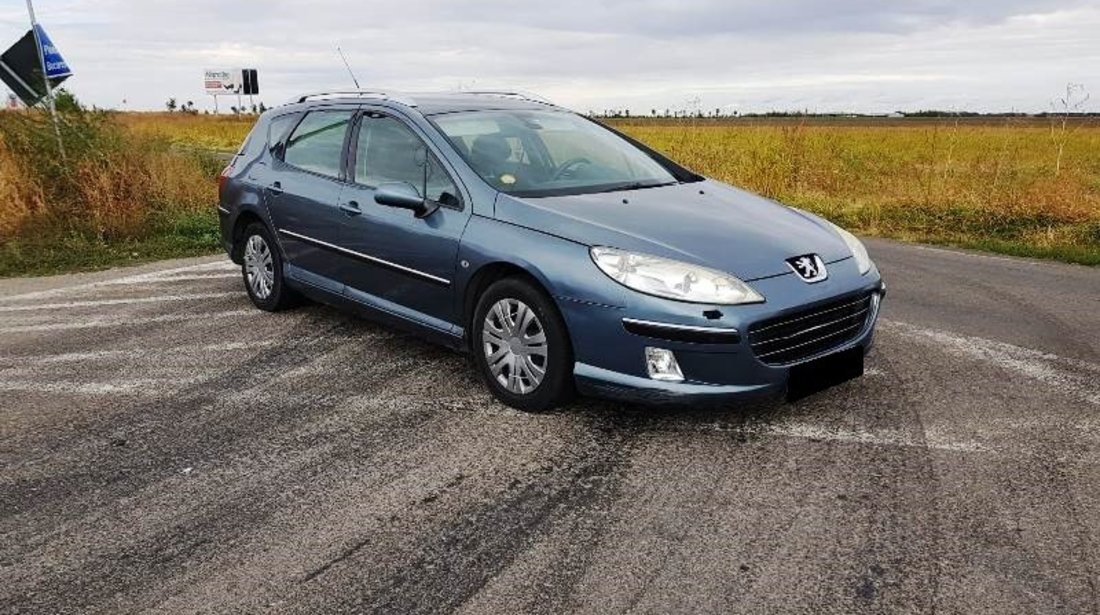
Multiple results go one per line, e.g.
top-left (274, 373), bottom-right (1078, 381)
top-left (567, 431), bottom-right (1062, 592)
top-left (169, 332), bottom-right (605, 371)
top-left (614, 119), bottom-right (1100, 265)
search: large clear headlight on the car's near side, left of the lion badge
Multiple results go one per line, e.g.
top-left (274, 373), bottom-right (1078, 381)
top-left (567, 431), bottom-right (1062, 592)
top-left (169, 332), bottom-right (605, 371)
top-left (591, 248), bottom-right (763, 306)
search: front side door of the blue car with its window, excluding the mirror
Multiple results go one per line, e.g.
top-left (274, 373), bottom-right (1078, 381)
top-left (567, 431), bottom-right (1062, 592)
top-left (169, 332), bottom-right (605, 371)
top-left (341, 112), bottom-right (471, 330)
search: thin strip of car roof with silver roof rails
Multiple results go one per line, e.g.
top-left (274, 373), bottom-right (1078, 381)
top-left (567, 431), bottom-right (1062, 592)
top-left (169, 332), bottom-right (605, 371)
top-left (281, 90), bottom-right (565, 116)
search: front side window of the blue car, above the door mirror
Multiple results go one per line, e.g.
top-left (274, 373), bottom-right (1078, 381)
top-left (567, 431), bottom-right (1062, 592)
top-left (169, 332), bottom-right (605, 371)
top-left (354, 116), bottom-right (462, 207)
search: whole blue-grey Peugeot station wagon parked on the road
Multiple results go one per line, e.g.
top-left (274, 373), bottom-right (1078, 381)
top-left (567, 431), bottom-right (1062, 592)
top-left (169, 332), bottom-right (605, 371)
top-left (218, 90), bottom-right (886, 410)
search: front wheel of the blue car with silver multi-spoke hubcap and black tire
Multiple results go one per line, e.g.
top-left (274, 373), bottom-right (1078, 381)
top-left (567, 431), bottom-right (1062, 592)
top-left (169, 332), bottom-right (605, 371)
top-left (470, 277), bottom-right (574, 411)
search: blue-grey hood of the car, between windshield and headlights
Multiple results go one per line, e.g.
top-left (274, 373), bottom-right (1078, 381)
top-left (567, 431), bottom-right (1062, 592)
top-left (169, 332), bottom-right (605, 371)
top-left (496, 180), bottom-right (851, 282)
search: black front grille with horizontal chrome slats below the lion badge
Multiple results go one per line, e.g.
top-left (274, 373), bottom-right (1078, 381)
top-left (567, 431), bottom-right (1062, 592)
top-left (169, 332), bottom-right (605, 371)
top-left (749, 293), bottom-right (875, 365)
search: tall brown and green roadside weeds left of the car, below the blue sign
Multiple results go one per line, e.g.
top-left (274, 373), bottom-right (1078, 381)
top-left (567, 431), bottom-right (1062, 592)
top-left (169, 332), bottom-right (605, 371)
top-left (0, 107), bottom-right (221, 276)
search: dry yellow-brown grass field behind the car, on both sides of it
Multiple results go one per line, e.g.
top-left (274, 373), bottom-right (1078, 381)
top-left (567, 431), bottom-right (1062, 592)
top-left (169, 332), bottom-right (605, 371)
top-left (0, 113), bottom-right (1100, 275)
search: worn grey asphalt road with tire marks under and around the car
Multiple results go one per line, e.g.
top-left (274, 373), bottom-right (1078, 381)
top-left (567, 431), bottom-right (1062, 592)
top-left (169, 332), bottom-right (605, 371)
top-left (0, 241), bottom-right (1100, 614)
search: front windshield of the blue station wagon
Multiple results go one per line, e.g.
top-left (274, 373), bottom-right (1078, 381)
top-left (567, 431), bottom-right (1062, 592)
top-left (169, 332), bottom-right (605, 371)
top-left (432, 111), bottom-right (677, 197)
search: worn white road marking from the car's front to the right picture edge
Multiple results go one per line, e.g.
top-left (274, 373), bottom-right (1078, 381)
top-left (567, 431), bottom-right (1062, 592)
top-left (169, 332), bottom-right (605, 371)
top-left (879, 319), bottom-right (1100, 405)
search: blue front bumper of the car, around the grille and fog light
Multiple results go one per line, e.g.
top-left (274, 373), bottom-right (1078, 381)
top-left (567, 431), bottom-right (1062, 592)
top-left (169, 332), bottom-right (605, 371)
top-left (561, 260), bottom-right (886, 405)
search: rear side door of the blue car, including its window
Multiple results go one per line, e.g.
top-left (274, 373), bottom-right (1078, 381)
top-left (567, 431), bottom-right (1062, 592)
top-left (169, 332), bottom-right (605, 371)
top-left (265, 108), bottom-right (355, 292)
